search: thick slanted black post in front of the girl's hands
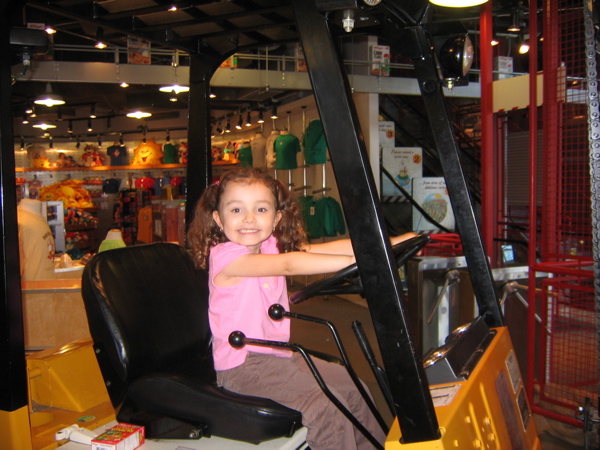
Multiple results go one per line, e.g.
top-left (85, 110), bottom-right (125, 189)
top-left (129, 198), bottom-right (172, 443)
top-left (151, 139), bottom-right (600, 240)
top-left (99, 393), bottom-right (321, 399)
top-left (292, 0), bottom-right (439, 443)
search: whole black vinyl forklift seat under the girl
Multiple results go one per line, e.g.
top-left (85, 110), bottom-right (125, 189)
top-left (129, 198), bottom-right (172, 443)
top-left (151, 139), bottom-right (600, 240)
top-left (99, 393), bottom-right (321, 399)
top-left (82, 243), bottom-right (302, 444)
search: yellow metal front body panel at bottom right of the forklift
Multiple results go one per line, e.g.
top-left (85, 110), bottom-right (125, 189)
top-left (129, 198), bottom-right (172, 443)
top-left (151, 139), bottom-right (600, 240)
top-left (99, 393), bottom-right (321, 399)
top-left (385, 327), bottom-right (541, 450)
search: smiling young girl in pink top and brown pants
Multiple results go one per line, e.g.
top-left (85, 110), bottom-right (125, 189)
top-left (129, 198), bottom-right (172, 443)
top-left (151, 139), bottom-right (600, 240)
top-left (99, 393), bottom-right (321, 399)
top-left (188, 169), bottom-right (414, 450)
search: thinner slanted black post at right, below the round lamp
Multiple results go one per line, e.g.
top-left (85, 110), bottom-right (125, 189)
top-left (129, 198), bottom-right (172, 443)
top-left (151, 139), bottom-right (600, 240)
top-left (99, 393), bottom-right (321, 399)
top-left (410, 26), bottom-right (504, 327)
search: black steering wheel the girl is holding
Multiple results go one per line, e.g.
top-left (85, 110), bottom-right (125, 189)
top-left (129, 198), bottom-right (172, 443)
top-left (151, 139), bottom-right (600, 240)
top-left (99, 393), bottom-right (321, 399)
top-left (290, 234), bottom-right (431, 304)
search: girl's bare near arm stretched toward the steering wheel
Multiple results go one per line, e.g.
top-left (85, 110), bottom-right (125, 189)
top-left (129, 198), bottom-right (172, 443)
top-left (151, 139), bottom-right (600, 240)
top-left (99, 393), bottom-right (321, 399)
top-left (215, 252), bottom-right (356, 286)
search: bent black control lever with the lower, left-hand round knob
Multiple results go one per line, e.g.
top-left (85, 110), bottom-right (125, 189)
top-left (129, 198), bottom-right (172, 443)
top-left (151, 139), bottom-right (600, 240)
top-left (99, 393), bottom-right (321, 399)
top-left (229, 331), bottom-right (383, 450)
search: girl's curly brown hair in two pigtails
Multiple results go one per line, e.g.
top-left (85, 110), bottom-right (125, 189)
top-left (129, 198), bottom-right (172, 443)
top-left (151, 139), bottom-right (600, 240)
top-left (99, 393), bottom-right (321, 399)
top-left (187, 168), bottom-right (308, 269)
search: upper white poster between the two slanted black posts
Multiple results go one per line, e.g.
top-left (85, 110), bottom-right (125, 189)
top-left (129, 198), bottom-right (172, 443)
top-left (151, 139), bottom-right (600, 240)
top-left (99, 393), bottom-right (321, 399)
top-left (381, 147), bottom-right (423, 202)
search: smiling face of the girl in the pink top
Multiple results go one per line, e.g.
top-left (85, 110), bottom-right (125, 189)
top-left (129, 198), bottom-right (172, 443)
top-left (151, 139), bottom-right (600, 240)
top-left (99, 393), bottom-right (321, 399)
top-left (213, 181), bottom-right (281, 253)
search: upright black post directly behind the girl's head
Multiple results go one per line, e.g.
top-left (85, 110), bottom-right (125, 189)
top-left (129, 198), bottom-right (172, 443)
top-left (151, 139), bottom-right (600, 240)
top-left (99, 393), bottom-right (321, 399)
top-left (185, 54), bottom-right (218, 232)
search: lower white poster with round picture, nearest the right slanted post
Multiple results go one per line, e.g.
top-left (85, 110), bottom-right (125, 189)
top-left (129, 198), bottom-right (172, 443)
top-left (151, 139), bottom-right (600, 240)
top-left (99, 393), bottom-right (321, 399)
top-left (412, 177), bottom-right (454, 231)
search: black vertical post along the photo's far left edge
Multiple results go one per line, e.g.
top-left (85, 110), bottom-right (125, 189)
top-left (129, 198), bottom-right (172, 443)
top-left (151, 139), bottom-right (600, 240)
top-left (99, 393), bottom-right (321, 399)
top-left (0, 2), bottom-right (27, 412)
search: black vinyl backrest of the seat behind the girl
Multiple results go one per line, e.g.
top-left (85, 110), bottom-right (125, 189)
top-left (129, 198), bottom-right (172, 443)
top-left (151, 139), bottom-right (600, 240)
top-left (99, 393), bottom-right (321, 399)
top-left (82, 243), bottom-right (215, 407)
